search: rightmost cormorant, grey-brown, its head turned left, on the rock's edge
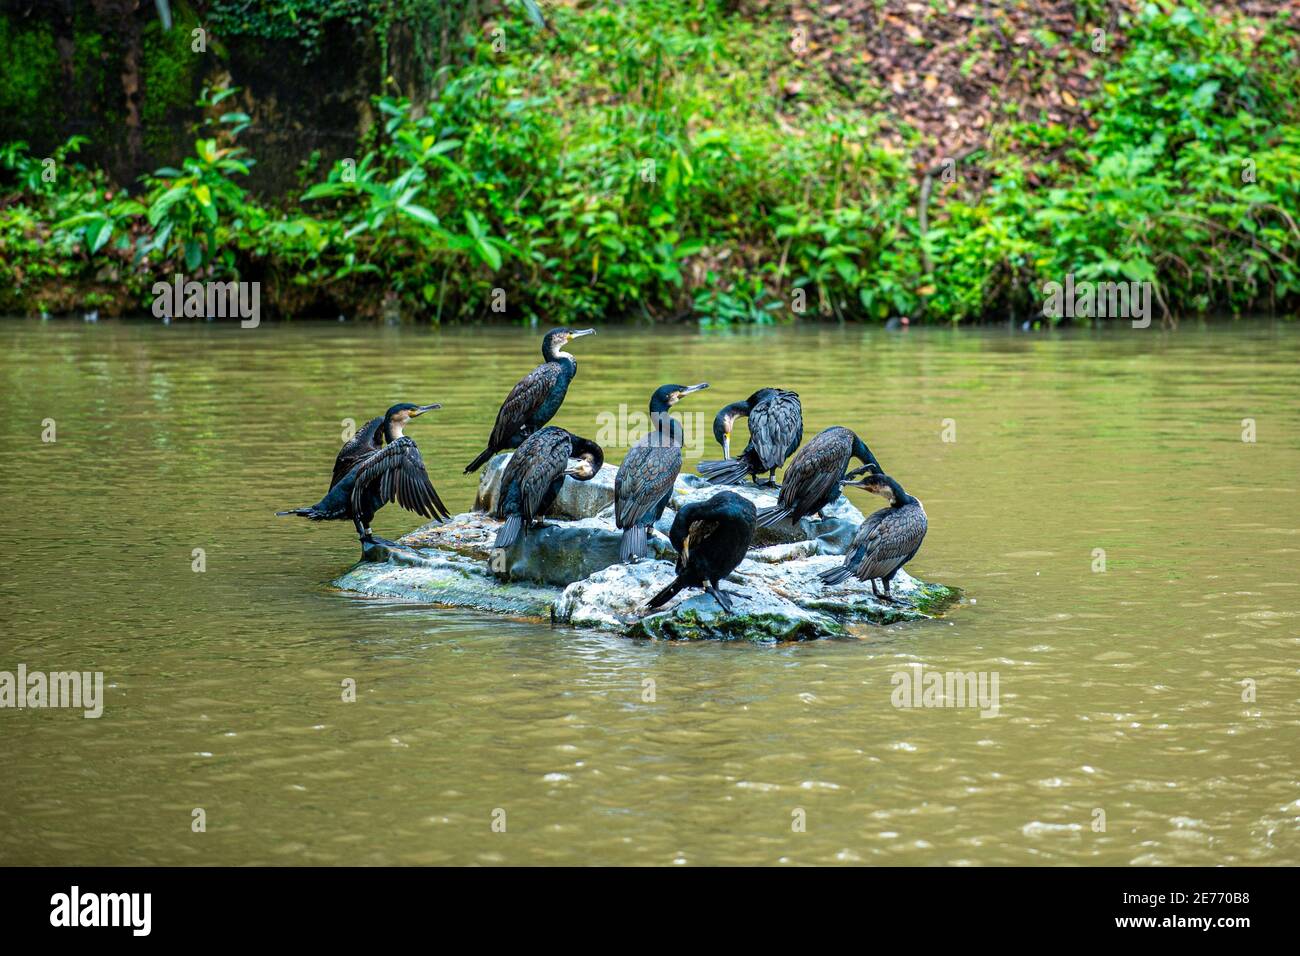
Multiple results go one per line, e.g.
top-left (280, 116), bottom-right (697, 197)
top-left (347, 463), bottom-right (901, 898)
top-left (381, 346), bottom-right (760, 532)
top-left (820, 475), bottom-right (927, 602)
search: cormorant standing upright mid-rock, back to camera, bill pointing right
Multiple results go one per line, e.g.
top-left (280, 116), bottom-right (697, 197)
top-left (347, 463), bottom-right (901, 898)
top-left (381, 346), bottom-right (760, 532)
top-left (614, 382), bottom-right (709, 562)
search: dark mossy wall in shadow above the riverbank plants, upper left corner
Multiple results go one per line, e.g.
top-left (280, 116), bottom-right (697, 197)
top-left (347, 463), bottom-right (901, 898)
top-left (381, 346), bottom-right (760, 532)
top-left (0, 0), bottom-right (480, 195)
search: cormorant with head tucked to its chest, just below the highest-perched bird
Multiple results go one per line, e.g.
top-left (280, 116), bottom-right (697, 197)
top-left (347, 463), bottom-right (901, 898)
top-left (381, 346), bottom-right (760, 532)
top-left (493, 425), bottom-right (605, 549)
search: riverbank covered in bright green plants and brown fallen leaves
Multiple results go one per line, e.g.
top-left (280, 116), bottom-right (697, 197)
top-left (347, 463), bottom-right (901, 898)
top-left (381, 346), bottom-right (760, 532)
top-left (0, 0), bottom-right (1300, 325)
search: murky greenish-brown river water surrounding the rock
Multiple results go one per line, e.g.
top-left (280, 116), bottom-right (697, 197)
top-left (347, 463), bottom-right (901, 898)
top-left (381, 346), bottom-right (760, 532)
top-left (0, 320), bottom-right (1300, 865)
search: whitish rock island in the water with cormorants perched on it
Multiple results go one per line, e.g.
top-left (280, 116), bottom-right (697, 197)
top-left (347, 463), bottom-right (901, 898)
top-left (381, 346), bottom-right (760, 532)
top-left (334, 465), bottom-right (958, 643)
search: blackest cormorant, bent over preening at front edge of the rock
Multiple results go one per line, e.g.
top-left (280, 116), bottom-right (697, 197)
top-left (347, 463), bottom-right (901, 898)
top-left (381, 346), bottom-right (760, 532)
top-left (646, 492), bottom-right (755, 614)
